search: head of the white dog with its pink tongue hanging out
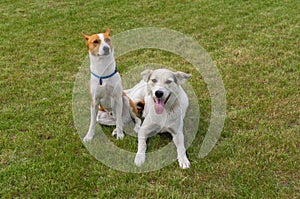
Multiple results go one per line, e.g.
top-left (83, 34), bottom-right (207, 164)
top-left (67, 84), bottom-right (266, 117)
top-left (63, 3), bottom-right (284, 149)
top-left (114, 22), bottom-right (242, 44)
top-left (141, 69), bottom-right (191, 114)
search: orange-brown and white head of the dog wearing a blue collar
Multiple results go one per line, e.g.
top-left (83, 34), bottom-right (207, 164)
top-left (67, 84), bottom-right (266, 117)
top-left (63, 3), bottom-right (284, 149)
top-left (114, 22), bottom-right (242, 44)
top-left (81, 28), bottom-right (113, 57)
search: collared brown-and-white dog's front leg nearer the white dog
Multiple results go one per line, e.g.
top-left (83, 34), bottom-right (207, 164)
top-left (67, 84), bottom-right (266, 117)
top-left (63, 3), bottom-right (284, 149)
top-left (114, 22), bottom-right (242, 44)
top-left (112, 97), bottom-right (124, 139)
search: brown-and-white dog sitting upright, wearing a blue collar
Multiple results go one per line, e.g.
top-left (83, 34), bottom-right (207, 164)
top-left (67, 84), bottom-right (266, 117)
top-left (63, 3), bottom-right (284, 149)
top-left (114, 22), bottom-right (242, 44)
top-left (82, 29), bottom-right (141, 142)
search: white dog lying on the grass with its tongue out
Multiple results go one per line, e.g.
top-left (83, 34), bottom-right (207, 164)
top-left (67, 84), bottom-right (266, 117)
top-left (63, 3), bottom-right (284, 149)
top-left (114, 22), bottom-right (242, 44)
top-left (135, 69), bottom-right (191, 169)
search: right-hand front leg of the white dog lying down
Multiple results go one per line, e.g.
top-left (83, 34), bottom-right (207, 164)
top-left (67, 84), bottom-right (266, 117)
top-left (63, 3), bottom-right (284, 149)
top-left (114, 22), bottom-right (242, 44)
top-left (172, 127), bottom-right (190, 169)
